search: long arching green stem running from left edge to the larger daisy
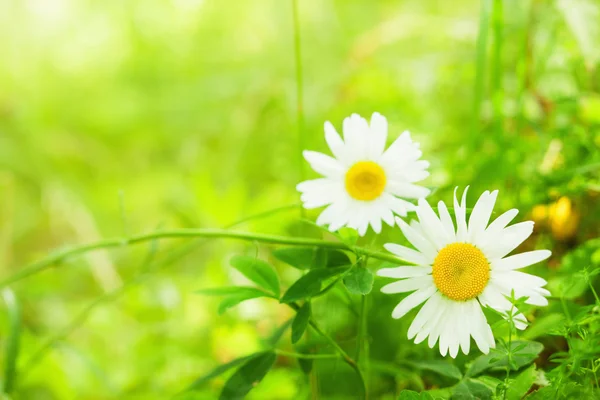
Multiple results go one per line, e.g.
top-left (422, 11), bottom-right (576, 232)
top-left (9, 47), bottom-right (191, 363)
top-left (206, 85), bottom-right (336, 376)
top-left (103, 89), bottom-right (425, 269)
top-left (0, 229), bottom-right (401, 288)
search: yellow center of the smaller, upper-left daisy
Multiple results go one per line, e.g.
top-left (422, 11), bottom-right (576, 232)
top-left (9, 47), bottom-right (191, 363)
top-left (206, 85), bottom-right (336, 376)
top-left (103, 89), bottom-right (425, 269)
top-left (346, 161), bottom-right (386, 201)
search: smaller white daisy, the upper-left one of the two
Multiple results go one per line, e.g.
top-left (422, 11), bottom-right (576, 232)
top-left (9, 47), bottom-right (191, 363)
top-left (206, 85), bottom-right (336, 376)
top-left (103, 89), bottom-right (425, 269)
top-left (296, 113), bottom-right (429, 236)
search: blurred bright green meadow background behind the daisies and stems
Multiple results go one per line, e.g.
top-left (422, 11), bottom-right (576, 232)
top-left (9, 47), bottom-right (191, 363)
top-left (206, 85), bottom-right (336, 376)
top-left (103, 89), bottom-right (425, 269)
top-left (0, 0), bottom-right (600, 399)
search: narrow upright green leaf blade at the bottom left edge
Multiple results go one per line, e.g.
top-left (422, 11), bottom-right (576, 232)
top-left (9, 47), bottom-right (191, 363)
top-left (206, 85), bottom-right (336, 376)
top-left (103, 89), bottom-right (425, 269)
top-left (0, 288), bottom-right (22, 394)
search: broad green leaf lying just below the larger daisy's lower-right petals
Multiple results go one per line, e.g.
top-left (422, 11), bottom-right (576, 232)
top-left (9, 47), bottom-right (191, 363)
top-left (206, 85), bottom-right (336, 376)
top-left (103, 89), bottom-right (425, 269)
top-left (466, 340), bottom-right (544, 376)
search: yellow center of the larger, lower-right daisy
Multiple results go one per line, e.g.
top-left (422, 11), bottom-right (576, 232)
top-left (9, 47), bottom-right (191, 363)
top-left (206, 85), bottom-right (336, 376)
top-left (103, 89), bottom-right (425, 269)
top-left (432, 243), bottom-right (490, 301)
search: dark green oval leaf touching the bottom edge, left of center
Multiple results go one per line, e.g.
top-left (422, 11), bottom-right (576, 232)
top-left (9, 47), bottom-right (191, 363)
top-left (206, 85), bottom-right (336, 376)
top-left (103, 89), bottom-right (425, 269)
top-left (219, 351), bottom-right (277, 400)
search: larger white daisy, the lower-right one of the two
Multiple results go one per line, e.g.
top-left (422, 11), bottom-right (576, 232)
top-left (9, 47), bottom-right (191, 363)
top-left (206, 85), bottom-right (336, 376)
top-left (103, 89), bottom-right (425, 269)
top-left (378, 188), bottom-right (551, 358)
